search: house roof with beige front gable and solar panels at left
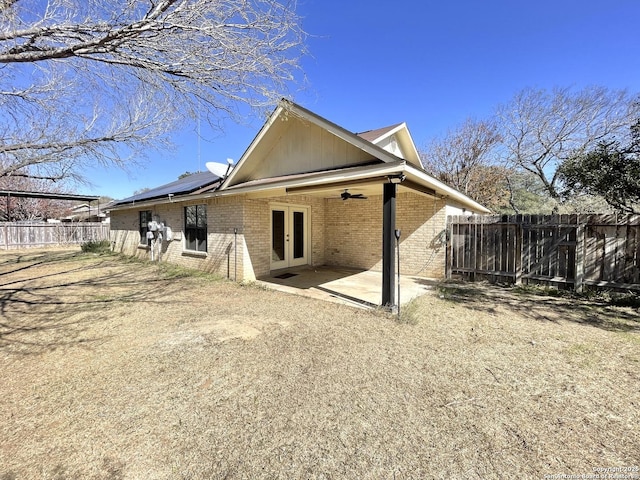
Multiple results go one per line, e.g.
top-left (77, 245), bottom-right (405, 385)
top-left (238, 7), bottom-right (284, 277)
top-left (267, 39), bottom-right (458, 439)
top-left (111, 101), bottom-right (489, 212)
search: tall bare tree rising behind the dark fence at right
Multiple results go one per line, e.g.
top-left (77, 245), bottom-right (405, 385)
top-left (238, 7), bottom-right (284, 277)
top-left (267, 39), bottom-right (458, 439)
top-left (497, 87), bottom-right (640, 201)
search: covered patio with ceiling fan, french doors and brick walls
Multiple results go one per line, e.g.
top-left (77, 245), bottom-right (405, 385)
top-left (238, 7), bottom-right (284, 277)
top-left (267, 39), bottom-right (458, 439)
top-left (227, 160), bottom-right (460, 311)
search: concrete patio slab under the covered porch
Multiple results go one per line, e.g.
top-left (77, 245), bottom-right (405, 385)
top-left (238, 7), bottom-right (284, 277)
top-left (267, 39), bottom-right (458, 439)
top-left (258, 265), bottom-right (437, 308)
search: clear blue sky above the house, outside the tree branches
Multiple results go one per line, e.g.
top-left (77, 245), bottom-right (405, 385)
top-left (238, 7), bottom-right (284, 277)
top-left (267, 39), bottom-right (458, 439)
top-left (80, 0), bottom-right (640, 198)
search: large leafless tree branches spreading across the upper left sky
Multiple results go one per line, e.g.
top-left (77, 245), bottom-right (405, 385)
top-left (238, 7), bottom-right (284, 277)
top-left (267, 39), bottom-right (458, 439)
top-left (0, 0), bottom-right (305, 180)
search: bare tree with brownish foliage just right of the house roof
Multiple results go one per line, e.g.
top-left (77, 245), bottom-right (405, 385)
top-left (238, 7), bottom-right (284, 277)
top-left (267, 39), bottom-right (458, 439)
top-left (421, 119), bottom-right (508, 209)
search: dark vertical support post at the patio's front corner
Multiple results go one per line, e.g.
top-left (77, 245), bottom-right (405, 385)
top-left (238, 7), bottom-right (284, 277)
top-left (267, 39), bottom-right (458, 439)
top-left (382, 183), bottom-right (397, 311)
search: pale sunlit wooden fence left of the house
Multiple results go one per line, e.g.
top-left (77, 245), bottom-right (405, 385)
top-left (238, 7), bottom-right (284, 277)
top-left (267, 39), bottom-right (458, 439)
top-left (0, 222), bottom-right (109, 250)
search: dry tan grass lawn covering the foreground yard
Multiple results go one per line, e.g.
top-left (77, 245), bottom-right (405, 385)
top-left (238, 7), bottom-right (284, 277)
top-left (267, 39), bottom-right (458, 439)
top-left (0, 250), bottom-right (640, 480)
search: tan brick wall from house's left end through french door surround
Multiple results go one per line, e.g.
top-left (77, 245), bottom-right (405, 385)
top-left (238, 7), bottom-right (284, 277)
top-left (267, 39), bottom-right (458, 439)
top-left (111, 192), bottom-right (325, 280)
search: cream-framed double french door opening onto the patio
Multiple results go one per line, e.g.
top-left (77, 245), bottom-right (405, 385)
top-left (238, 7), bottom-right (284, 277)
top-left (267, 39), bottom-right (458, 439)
top-left (271, 205), bottom-right (309, 270)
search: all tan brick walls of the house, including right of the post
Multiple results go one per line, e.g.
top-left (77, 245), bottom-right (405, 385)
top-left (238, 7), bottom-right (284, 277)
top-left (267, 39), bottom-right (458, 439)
top-left (111, 193), bottom-right (446, 280)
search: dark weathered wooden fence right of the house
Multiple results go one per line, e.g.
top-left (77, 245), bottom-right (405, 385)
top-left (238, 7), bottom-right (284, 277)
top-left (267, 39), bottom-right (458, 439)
top-left (447, 215), bottom-right (640, 291)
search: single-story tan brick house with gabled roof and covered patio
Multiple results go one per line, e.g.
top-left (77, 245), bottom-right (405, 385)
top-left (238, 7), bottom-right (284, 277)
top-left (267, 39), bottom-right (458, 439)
top-left (111, 101), bottom-right (488, 305)
